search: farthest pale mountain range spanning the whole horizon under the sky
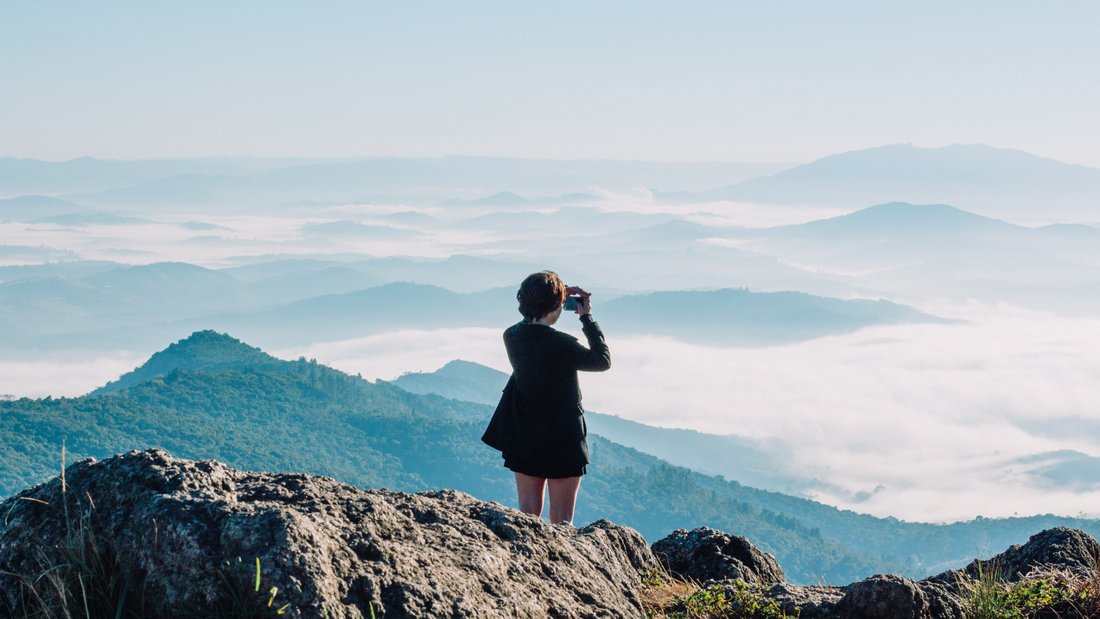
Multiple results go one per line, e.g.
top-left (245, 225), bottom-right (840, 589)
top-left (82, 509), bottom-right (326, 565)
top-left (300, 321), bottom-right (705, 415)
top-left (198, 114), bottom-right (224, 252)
top-left (0, 144), bottom-right (1100, 223)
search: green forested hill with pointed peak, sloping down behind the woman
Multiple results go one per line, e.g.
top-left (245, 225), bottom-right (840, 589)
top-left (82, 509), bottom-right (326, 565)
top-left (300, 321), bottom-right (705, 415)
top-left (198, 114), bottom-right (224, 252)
top-left (0, 332), bottom-right (902, 583)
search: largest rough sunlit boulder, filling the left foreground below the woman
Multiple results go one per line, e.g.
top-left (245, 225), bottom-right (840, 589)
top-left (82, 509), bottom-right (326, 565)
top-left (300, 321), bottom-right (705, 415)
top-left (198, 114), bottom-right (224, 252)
top-left (0, 450), bottom-right (657, 619)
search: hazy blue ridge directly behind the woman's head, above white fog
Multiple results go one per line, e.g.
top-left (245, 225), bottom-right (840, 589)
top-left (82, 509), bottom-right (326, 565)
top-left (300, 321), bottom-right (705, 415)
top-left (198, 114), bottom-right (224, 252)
top-left (177, 283), bottom-right (943, 346)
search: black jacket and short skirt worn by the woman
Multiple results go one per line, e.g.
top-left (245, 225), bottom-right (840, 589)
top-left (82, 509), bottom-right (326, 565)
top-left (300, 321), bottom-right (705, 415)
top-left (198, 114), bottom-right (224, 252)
top-left (482, 316), bottom-right (612, 466)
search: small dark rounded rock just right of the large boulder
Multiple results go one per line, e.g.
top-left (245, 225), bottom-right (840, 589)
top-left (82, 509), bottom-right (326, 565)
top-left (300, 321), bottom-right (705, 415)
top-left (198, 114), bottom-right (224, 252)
top-left (651, 527), bottom-right (785, 585)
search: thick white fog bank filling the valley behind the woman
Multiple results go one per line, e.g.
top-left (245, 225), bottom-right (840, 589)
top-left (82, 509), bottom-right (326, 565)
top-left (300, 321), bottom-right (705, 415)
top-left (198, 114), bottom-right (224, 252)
top-left (272, 308), bottom-right (1100, 522)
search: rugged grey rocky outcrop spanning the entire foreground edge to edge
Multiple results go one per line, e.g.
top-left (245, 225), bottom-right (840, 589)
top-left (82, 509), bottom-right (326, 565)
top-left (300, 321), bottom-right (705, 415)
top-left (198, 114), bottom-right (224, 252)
top-left (0, 450), bottom-right (1100, 619)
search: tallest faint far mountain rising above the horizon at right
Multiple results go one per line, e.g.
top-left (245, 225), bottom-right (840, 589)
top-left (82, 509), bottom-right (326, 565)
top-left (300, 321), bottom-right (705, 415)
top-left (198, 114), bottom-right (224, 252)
top-left (662, 144), bottom-right (1100, 223)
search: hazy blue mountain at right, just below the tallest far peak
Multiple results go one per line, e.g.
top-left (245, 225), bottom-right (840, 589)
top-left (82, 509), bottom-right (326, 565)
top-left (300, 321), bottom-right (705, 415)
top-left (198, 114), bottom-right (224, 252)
top-left (722, 202), bottom-right (1100, 313)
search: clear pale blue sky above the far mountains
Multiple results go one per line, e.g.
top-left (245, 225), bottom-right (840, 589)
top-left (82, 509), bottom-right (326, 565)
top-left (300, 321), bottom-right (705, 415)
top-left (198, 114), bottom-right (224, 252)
top-left (0, 0), bottom-right (1100, 167)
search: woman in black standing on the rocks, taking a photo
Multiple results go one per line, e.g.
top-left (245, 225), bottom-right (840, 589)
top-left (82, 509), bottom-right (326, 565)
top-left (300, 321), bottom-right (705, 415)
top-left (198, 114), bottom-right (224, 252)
top-left (482, 270), bottom-right (612, 524)
